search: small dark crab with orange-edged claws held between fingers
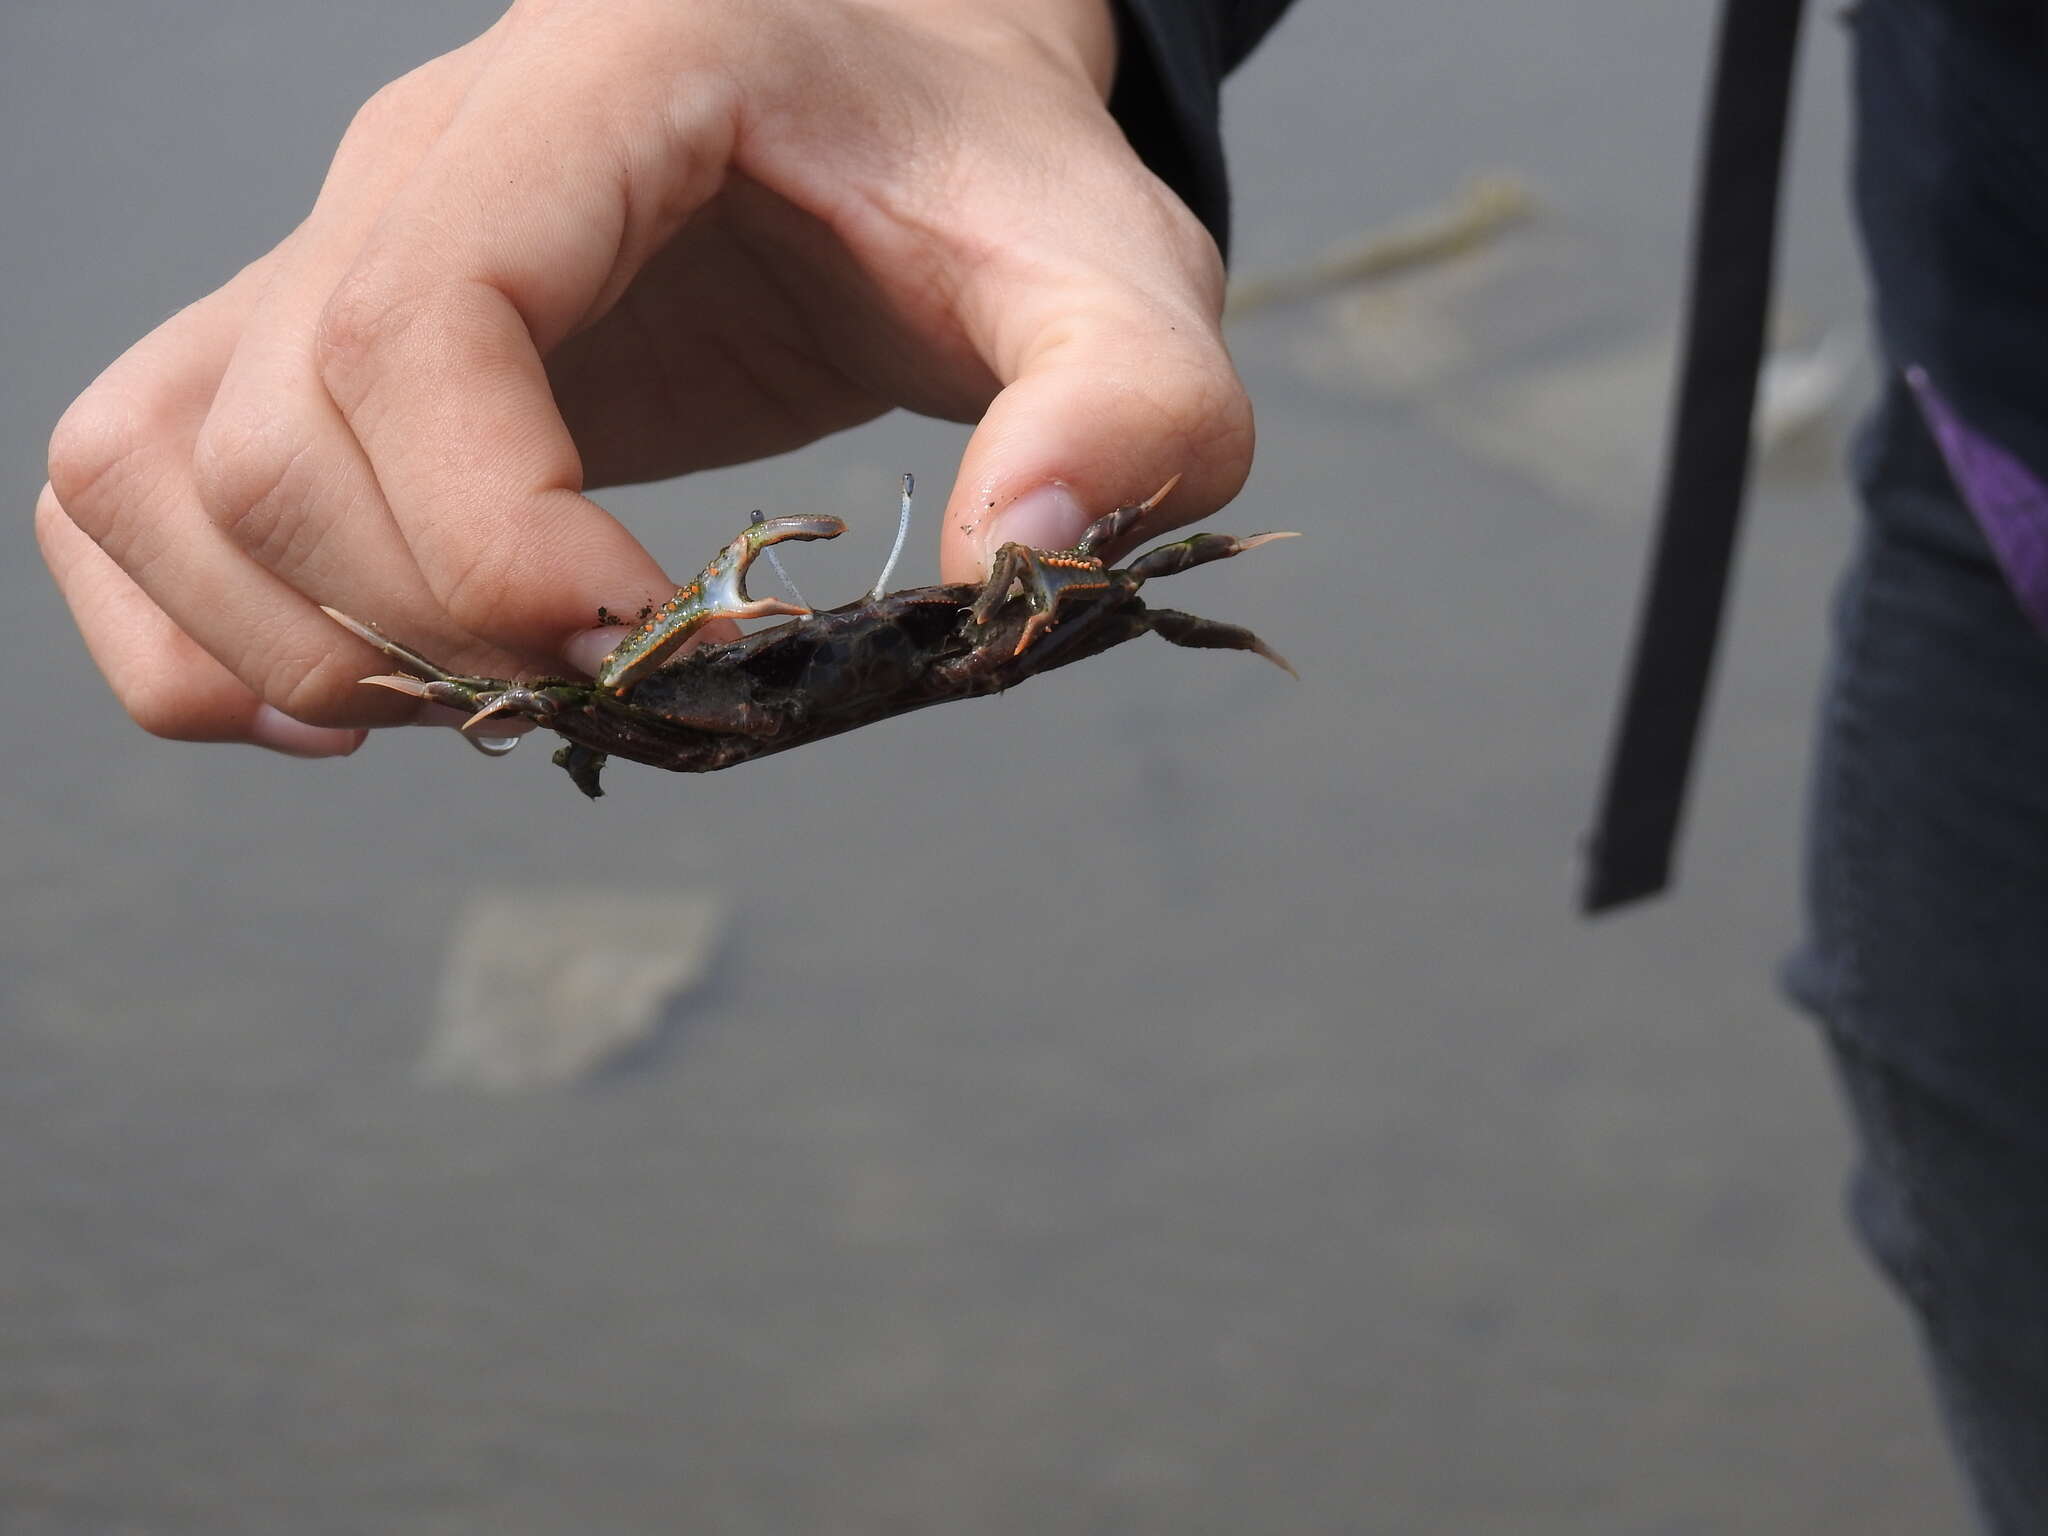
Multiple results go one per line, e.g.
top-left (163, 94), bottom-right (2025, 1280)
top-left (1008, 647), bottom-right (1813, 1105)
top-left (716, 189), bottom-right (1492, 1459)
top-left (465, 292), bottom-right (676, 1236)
top-left (326, 475), bottom-right (1294, 799)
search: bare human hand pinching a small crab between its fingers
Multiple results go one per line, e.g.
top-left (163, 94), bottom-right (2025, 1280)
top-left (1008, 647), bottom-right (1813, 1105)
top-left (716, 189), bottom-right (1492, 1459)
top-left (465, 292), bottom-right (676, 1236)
top-left (37, 0), bottom-right (1251, 756)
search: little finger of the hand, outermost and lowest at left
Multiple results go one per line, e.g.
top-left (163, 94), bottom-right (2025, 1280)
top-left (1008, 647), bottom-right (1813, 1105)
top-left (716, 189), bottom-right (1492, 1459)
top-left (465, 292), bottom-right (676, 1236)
top-left (35, 485), bottom-right (362, 758)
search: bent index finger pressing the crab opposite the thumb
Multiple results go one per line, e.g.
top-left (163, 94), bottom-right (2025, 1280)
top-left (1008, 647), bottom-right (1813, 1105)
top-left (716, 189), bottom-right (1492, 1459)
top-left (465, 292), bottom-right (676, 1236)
top-left (319, 33), bottom-right (731, 653)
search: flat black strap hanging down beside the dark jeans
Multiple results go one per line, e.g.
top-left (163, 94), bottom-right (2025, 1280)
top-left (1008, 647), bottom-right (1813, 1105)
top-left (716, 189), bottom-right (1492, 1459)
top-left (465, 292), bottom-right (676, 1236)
top-left (1579, 0), bottom-right (1800, 911)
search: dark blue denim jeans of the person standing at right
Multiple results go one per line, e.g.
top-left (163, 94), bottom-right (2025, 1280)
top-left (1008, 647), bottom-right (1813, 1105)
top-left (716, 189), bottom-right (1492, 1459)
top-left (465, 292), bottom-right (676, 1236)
top-left (1788, 0), bottom-right (2048, 1536)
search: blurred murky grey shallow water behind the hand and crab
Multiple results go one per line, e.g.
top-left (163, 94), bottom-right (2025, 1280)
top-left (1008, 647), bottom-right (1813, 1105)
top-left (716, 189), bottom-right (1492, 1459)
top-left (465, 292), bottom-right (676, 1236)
top-left (0, 0), bottom-right (1960, 1536)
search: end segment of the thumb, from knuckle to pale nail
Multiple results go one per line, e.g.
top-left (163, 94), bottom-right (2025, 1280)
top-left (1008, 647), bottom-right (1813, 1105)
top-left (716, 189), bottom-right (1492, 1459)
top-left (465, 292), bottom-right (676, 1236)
top-left (940, 307), bottom-right (1253, 582)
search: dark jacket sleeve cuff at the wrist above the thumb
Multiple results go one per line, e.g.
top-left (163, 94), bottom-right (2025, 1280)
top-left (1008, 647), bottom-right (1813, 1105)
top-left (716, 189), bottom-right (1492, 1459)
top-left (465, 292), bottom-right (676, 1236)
top-left (1110, 0), bottom-right (1288, 256)
